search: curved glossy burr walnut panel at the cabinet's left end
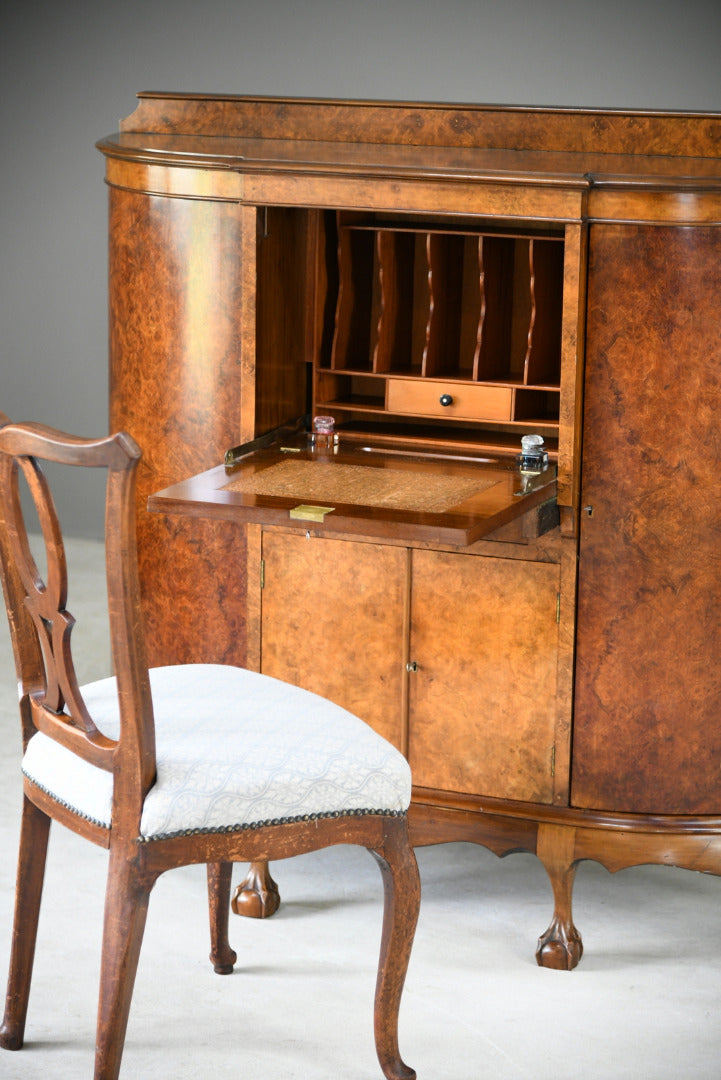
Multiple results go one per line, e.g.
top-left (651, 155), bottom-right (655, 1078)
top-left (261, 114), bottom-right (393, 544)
top-left (110, 188), bottom-right (245, 664)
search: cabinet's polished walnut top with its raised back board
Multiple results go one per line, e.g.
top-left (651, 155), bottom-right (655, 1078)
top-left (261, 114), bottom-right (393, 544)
top-left (98, 92), bottom-right (721, 190)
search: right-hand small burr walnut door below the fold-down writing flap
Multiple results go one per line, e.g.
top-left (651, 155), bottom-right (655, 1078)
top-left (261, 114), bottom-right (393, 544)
top-left (409, 551), bottom-right (560, 802)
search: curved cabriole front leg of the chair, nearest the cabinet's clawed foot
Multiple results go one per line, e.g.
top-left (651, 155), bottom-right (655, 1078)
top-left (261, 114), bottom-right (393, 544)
top-left (371, 818), bottom-right (421, 1080)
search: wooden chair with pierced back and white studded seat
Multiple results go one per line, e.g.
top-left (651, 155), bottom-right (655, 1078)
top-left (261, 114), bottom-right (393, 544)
top-left (0, 414), bottom-right (420, 1080)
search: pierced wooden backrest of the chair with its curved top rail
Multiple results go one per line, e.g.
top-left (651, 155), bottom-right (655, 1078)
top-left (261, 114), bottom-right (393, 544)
top-left (0, 412), bottom-right (155, 835)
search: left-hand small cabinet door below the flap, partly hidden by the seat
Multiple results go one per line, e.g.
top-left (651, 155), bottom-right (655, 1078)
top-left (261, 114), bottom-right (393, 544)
top-left (260, 532), bottom-right (408, 750)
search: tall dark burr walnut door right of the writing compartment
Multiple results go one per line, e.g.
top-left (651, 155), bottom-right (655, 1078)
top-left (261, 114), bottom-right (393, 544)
top-left (572, 225), bottom-right (721, 813)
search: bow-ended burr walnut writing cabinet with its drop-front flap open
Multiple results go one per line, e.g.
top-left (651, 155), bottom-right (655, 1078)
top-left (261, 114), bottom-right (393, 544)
top-left (98, 93), bottom-right (721, 968)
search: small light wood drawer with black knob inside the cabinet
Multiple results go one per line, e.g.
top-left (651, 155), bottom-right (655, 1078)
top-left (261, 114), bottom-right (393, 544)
top-left (386, 379), bottom-right (513, 420)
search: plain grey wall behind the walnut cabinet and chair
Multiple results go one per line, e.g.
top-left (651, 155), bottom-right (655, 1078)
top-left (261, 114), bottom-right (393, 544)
top-left (0, 0), bottom-right (721, 536)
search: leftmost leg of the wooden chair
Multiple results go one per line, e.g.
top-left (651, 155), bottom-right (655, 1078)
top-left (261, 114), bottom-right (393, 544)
top-left (0, 796), bottom-right (51, 1050)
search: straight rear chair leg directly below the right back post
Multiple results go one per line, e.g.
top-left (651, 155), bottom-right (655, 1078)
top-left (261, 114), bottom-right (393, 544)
top-left (95, 847), bottom-right (155, 1080)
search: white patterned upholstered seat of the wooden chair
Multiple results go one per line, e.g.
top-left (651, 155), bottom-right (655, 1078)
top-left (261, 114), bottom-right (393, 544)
top-left (23, 664), bottom-right (411, 841)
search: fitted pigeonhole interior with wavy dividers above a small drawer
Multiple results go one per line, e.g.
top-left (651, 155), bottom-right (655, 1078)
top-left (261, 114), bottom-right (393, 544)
top-left (314, 219), bottom-right (563, 438)
